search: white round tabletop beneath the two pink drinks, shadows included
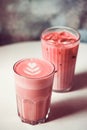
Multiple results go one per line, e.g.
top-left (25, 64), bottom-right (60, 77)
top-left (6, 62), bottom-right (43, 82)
top-left (0, 42), bottom-right (87, 130)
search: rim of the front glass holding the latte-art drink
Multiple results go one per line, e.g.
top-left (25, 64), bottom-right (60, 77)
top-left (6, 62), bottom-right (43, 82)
top-left (13, 58), bottom-right (55, 80)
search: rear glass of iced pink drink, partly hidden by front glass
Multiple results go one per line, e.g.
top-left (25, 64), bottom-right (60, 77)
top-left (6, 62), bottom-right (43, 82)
top-left (41, 27), bottom-right (80, 92)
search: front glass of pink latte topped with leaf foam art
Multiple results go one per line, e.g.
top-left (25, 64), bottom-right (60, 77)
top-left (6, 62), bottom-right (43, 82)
top-left (13, 58), bottom-right (54, 124)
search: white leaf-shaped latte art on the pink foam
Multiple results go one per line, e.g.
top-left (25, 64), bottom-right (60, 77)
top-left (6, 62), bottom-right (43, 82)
top-left (24, 62), bottom-right (41, 75)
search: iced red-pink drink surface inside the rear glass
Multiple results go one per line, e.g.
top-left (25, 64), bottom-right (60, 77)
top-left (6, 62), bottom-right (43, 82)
top-left (42, 31), bottom-right (77, 45)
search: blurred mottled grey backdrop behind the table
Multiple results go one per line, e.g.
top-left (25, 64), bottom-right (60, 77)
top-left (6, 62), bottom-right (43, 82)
top-left (0, 0), bottom-right (87, 45)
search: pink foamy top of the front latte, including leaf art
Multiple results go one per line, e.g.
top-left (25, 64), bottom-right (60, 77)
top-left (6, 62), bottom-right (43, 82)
top-left (14, 58), bottom-right (54, 78)
